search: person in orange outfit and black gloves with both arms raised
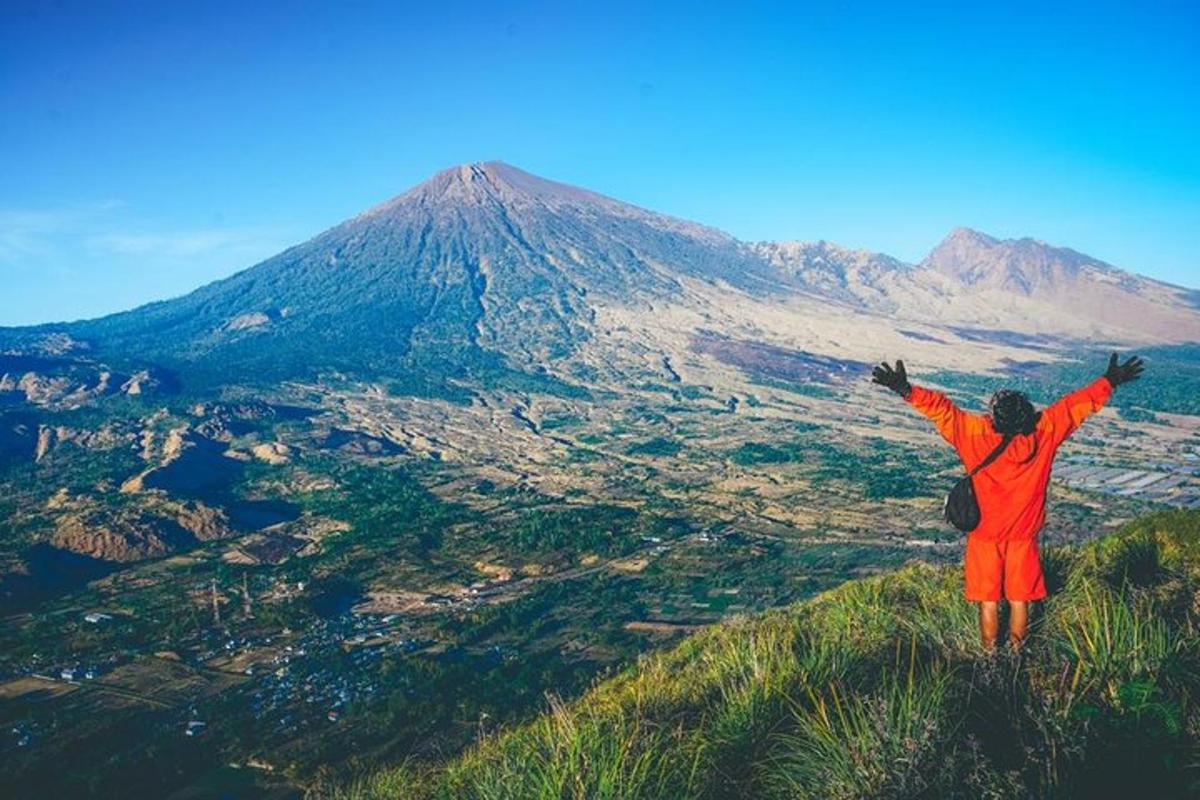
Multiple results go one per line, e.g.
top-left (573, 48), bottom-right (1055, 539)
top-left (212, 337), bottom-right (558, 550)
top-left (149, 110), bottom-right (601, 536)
top-left (871, 353), bottom-right (1144, 651)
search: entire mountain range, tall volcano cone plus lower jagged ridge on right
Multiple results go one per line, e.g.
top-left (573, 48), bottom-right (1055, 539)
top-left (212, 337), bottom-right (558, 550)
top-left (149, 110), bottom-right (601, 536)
top-left (0, 162), bottom-right (1200, 391)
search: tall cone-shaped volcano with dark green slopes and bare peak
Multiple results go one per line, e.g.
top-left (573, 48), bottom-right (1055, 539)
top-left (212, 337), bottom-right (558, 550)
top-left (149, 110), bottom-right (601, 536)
top-left (46, 162), bottom-right (792, 383)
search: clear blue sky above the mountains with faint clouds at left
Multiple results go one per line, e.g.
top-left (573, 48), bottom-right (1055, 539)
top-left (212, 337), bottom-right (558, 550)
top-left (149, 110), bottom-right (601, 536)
top-left (0, 0), bottom-right (1200, 324)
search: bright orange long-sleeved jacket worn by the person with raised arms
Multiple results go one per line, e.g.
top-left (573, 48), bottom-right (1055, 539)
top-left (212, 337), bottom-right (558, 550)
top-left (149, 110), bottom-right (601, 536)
top-left (908, 377), bottom-right (1112, 541)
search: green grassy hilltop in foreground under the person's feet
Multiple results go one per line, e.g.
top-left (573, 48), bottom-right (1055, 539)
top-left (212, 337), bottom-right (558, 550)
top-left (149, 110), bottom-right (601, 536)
top-left (331, 511), bottom-right (1200, 800)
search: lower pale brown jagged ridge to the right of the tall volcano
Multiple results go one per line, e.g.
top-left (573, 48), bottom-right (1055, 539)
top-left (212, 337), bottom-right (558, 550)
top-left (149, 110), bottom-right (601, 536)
top-left (754, 228), bottom-right (1200, 342)
